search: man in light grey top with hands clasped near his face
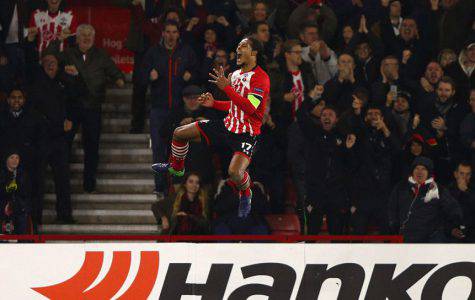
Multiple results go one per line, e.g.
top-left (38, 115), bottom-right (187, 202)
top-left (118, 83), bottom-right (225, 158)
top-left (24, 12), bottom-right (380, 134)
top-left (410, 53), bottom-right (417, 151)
top-left (299, 23), bottom-right (338, 85)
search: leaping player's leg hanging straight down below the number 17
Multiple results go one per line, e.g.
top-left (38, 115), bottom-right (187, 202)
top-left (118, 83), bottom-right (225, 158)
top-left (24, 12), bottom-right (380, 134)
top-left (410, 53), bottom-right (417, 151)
top-left (228, 153), bottom-right (252, 218)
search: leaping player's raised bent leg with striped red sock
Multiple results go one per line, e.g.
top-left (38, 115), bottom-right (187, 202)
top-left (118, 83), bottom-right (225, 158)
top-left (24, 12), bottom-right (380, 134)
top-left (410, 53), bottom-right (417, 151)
top-left (152, 122), bottom-right (201, 177)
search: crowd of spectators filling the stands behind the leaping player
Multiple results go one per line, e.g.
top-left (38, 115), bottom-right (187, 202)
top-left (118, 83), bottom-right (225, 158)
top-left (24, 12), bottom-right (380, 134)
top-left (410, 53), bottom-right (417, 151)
top-left (0, 0), bottom-right (475, 242)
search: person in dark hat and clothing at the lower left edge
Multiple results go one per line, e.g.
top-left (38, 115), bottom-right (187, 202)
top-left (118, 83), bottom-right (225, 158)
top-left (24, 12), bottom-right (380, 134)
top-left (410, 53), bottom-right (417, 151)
top-left (0, 148), bottom-right (31, 234)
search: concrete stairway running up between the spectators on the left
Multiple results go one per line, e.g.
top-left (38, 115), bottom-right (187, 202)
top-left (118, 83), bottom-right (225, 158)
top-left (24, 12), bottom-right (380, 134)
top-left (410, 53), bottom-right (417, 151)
top-left (41, 86), bottom-right (159, 234)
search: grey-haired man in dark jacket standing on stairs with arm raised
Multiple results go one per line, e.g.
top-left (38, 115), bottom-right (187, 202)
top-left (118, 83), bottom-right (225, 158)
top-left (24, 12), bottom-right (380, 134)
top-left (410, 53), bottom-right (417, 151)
top-left (51, 24), bottom-right (125, 193)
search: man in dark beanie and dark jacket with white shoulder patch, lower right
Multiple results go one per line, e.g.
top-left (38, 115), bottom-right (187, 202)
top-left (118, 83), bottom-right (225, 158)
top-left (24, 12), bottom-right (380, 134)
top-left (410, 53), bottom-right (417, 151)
top-left (388, 156), bottom-right (464, 243)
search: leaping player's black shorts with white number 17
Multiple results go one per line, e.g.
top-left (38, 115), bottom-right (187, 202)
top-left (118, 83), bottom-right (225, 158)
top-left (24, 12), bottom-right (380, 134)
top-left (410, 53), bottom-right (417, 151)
top-left (195, 120), bottom-right (257, 160)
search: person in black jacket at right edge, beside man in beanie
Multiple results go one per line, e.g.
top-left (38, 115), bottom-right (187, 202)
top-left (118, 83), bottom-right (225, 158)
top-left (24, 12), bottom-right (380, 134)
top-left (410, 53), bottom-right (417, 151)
top-left (449, 162), bottom-right (475, 243)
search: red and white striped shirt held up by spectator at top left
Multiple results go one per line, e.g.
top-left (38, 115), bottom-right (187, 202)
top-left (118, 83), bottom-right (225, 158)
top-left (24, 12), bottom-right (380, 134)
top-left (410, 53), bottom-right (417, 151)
top-left (30, 9), bottom-right (77, 55)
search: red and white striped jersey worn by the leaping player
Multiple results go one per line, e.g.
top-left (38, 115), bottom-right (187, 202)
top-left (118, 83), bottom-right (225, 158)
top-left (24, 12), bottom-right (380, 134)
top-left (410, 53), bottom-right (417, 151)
top-left (224, 66), bottom-right (270, 136)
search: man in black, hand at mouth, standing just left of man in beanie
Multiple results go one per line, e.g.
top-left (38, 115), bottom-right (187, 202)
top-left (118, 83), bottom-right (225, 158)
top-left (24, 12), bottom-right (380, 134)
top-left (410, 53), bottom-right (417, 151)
top-left (351, 106), bottom-right (401, 234)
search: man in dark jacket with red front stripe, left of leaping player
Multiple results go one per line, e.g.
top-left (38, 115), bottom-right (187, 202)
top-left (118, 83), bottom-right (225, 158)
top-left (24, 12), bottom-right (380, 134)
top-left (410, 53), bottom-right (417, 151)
top-left (141, 21), bottom-right (198, 193)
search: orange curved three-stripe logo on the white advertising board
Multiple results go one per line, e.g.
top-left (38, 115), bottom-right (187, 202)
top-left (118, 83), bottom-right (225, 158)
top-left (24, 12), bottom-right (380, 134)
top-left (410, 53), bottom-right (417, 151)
top-left (32, 251), bottom-right (159, 300)
